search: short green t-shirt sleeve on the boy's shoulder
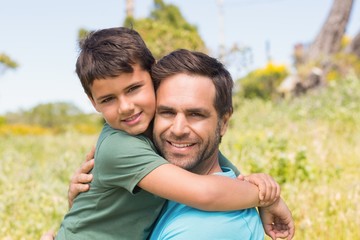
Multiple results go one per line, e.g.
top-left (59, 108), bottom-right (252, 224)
top-left (95, 133), bottom-right (168, 192)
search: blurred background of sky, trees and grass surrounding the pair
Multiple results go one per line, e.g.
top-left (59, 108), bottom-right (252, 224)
top-left (0, 0), bottom-right (360, 240)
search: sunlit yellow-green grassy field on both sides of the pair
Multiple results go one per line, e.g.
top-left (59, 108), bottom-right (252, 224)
top-left (0, 77), bottom-right (360, 240)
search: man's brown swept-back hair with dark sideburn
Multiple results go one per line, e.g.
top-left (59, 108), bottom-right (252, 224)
top-left (151, 49), bottom-right (234, 118)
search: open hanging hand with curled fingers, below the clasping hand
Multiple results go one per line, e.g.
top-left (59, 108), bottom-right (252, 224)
top-left (259, 198), bottom-right (295, 240)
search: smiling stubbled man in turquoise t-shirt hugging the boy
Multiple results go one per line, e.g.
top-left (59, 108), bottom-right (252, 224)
top-left (43, 50), bottom-right (294, 239)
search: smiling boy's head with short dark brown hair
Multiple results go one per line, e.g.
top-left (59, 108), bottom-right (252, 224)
top-left (76, 28), bottom-right (155, 135)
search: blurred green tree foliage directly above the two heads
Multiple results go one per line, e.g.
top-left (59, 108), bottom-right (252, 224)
top-left (124, 0), bottom-right (207, 59)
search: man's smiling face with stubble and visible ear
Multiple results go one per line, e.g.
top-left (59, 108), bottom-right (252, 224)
top-left (154, 74), bottom-right (228, 174)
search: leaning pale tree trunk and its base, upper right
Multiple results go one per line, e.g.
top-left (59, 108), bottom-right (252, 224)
top-left (279, 0), bottom-right (360, 95)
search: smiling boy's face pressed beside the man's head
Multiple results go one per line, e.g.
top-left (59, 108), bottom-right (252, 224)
top-left (90, 65), bottom-right (155, 135)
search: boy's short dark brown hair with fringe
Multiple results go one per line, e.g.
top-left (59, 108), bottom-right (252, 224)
top-left (76, 27), bottom-right (155, 97)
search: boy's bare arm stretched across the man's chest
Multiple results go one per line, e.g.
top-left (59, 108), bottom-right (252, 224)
top-left (138, 164), bottom-right (275, 211)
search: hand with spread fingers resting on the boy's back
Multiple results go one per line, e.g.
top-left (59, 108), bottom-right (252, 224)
top-left (68, 147), bottom-right (95, 208)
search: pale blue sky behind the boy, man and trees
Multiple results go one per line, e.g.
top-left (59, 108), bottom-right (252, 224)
top-left (0, 0), bottom-right (360, 114)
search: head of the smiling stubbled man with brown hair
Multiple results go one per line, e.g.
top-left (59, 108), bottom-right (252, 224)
top-left (152, 50), bottom-right (233, 174)
